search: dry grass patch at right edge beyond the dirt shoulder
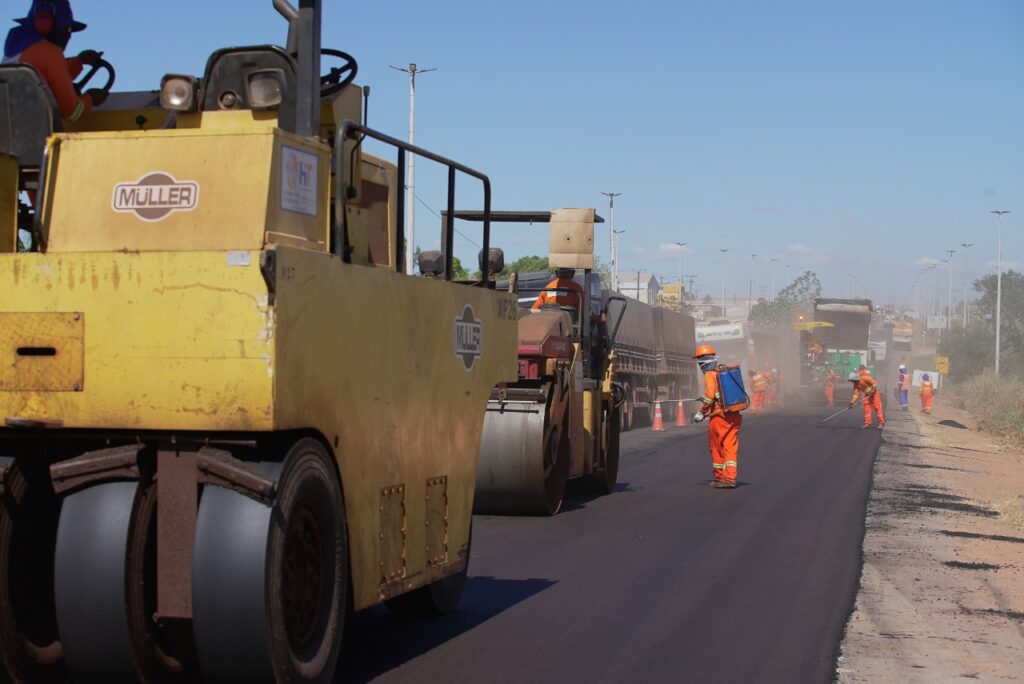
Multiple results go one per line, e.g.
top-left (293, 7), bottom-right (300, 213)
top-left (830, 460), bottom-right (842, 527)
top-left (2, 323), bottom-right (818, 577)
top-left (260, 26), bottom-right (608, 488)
top-left (946, 371), bottom-right (1024, 443)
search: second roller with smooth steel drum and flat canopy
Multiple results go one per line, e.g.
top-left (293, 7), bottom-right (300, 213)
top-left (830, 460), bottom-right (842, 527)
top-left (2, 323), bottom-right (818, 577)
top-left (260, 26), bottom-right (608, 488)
top-left (468, 209), bottom-right (632, 515)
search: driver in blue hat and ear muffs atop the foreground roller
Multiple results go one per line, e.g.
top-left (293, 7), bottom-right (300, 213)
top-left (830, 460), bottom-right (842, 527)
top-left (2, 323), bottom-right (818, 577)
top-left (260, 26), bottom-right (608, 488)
top-left (3, 0), bottom-right (106, 122)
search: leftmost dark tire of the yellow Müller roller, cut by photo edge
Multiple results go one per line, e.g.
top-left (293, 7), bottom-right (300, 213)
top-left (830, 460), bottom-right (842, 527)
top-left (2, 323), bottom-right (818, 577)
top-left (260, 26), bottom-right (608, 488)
top-left (0, 458), bottom-right (70, 684)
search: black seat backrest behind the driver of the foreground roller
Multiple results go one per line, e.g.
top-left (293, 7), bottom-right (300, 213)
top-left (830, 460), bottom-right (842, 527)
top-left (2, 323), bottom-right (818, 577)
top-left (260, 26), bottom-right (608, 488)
top-left (0, 65), bottom-right (61, 168)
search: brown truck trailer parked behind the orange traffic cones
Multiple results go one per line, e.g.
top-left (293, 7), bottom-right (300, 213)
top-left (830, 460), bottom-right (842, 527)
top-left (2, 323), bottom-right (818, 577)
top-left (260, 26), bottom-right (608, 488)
top-left (614, 299), bottom-right (697, 430)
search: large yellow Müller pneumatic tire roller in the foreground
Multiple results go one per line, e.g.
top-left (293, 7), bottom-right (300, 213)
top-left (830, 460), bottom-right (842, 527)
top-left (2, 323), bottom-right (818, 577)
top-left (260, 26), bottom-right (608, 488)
top-left (0, 0), bottom-right (516, 683)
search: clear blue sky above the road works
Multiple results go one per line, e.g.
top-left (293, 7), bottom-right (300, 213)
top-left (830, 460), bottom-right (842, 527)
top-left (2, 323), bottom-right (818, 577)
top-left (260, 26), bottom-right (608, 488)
top-left (48, 0), bottom-right (1024, 302)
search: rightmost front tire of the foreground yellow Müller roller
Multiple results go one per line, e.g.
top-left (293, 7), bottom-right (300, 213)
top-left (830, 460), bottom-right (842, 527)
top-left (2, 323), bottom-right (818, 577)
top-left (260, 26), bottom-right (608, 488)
top-left (193, 438), bottom-right (348, 683)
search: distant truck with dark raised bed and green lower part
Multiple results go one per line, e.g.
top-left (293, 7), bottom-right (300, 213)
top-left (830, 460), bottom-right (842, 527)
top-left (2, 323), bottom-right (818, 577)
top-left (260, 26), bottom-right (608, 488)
top-left (814, 297), bottom-right (879, 393)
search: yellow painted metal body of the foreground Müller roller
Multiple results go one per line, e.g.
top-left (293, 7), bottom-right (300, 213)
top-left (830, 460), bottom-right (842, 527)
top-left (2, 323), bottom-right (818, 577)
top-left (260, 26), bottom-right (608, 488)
top-left (0, 96), bottom-right (516, 608)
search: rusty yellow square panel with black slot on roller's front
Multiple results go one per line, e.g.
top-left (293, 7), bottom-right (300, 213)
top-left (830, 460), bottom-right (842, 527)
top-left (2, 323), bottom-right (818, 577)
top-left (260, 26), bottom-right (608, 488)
top-left (0, 312), bottom-right (85, 392)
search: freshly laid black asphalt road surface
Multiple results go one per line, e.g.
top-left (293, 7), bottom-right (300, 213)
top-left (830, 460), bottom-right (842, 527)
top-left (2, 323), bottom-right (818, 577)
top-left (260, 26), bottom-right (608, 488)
top-left (339, 407), bottom-right (880, 683)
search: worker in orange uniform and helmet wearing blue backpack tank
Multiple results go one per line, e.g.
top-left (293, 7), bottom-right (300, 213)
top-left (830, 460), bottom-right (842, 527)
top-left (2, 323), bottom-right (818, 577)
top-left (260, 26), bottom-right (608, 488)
top-left (693, 344), bottom-right (743, 489)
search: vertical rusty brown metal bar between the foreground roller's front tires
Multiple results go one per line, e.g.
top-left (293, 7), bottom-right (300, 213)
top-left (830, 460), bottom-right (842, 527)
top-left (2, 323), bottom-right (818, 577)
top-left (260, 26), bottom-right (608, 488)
top-left (157, 452), bottom-right (198, 619)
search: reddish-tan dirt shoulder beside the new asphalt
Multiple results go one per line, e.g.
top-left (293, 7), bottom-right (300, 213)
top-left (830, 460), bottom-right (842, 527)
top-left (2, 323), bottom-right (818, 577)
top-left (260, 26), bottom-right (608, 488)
top-left (836, 397), bottom-right (1024, 684)
